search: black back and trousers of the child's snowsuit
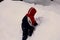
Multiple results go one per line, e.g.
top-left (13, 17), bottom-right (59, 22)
top-left (22, 16), bottom-right (34, 40)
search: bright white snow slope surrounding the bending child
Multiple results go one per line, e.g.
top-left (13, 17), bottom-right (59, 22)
top-left (0, 1), bottom-right (60, 40)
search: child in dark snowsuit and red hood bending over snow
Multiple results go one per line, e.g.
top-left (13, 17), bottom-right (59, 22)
top-left (22, 7), bottom-right (37, 40)
